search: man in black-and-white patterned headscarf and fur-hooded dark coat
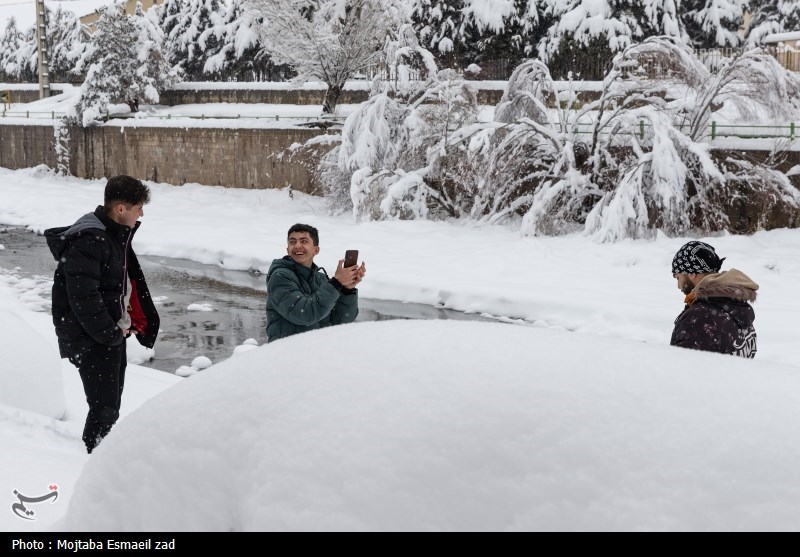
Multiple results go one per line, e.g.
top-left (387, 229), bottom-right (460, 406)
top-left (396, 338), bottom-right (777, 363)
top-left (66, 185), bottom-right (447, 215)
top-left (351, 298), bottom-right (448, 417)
top-left (670, 241), bottom-right (758, 358)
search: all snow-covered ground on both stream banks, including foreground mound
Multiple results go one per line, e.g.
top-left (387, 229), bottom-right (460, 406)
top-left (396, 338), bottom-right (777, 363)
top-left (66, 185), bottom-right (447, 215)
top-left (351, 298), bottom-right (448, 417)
top-left (0, 168), bottom-right (800, 531)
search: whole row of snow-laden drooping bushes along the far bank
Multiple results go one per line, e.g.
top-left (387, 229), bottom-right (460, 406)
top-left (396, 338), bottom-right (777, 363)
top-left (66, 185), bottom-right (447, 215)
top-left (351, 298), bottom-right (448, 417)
top-left (324, 37), bottom-right (800, 241)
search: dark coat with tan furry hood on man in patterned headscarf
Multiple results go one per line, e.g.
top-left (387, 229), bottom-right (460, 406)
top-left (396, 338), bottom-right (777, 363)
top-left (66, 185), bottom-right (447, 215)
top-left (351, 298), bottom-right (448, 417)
top-left (670, 269), bottom-right (758, 358)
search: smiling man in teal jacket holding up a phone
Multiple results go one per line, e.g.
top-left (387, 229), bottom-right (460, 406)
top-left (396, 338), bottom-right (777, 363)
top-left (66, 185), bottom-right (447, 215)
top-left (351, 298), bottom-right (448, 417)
top-left (267, 224), bottom-right (366, 342)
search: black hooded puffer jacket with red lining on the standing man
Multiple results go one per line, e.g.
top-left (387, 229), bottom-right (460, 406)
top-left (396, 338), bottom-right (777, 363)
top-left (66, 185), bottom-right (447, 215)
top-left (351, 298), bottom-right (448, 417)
top-left (45, 206), bottom-right (159, 357)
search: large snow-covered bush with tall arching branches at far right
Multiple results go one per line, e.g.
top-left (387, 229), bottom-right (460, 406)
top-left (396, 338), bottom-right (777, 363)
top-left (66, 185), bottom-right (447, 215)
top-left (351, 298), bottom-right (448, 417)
top-left (564, 39), bottom-right (800, 241)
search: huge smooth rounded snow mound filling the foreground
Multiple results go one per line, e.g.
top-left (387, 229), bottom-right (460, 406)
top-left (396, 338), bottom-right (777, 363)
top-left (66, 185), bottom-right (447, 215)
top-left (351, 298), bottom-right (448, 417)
top-left (63, 321), bottom-right (800, 531)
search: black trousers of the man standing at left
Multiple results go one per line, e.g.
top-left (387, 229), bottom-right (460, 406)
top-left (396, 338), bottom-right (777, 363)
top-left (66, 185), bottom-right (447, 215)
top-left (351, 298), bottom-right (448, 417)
top-left (59, 340), bottom-right (128, 453)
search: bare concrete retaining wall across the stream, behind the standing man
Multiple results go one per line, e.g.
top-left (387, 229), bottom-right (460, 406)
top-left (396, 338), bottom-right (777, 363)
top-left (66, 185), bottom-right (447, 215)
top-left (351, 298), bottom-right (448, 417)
top-left (0, 125), bottom-right (332, 193)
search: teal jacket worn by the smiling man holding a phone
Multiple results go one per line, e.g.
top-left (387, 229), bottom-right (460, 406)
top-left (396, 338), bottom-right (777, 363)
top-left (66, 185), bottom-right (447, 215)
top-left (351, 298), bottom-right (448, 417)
top-left (267, 255), bottom-right (358, 342)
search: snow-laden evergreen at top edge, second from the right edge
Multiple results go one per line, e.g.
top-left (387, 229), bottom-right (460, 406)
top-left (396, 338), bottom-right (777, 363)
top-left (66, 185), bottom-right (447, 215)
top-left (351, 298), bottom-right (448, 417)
top-left (681, 0), bottom-right (749, 48)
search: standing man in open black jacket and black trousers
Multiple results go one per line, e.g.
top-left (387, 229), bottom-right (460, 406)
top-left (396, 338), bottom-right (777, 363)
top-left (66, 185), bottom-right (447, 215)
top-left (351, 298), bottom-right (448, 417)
top-left (45, 176), bottom-right (159, 453)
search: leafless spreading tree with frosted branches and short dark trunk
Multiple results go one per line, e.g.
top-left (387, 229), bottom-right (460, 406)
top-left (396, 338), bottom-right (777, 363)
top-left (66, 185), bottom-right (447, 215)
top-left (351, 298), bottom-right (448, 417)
top-left (248, 0), bottom-right (406, 113)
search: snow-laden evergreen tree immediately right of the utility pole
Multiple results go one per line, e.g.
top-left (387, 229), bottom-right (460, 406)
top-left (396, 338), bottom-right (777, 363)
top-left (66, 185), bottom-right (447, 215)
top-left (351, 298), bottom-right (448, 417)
top-left (47, 4), bottom-right (88, 81)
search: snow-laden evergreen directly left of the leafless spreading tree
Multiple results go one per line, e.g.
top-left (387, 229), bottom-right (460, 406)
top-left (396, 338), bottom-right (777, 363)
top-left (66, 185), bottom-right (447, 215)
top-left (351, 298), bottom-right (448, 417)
top-left (203, 0), bottom-right (282, 81)
